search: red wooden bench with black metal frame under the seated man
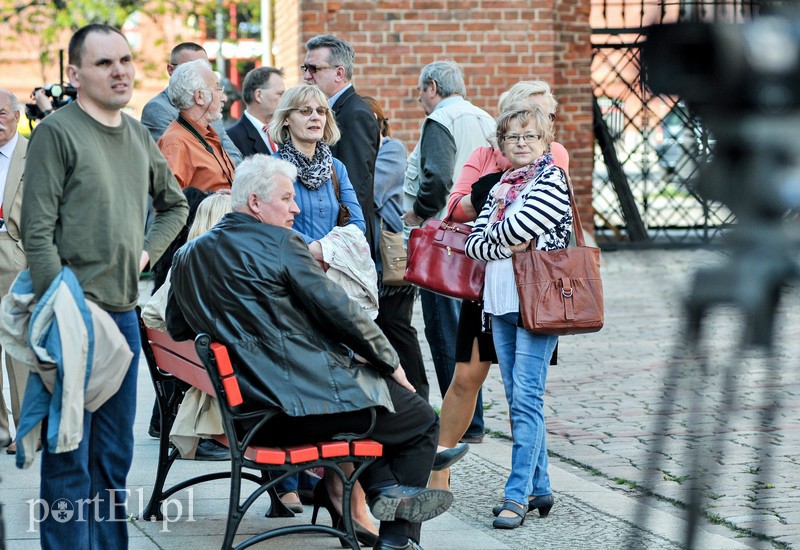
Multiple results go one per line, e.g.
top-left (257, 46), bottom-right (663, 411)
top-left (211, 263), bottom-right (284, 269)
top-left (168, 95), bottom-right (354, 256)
top-left (139, 317), bottom-right (383, 550)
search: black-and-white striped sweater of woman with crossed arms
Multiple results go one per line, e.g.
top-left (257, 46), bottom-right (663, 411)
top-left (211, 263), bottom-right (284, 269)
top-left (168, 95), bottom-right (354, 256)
top-left (466, 165), bottom-right (572, 261)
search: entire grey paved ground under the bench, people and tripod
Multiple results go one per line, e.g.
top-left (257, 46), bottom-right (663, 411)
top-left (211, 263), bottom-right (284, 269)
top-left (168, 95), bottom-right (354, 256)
top-left (0, 250), bottom-right (800, 550)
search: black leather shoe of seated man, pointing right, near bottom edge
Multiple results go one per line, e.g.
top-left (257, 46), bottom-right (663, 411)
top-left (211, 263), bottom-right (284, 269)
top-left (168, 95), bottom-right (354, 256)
top-left (368, 485), bottom-right (453, 523)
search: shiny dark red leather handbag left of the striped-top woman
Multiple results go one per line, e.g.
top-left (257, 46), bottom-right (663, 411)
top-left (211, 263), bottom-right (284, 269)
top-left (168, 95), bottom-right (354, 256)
top-left (403, 205), bottom-right (486, 302)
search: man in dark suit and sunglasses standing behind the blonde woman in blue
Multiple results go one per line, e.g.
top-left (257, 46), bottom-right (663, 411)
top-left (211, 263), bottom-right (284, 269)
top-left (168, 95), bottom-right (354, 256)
top-left (300, 34), bottom-right (381, 260)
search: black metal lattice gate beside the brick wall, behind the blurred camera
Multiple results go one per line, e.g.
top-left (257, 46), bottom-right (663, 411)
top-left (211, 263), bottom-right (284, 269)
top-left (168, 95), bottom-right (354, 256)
top-left (592, 0), bottom-right (788, 247)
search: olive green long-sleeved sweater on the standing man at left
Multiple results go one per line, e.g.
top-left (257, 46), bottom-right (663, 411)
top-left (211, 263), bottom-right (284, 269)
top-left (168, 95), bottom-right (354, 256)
top-left (21, 103), bottom-right (188, 312)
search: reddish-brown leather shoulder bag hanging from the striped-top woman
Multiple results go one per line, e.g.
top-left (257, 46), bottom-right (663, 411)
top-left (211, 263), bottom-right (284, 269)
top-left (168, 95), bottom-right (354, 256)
top-left (512, 174), bottom-right (604, 336)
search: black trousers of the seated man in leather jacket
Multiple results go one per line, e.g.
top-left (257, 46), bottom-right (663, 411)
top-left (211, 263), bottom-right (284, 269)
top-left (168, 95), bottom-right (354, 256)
top-left (256, 379), bottom-right (439, 542)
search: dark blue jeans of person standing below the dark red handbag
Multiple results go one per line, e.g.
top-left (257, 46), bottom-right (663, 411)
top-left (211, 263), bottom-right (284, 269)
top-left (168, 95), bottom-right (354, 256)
top-left (419, 289), bottom-right (484, 436)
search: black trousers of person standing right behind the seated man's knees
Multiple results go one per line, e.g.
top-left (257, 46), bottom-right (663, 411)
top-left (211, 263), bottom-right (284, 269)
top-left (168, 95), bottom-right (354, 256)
top-left (375, 288), bottom-right (430, 401)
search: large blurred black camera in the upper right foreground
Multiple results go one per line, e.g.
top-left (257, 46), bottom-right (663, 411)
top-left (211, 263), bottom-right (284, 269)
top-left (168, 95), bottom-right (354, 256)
top-left (643, 11), bottom-right (800, 221)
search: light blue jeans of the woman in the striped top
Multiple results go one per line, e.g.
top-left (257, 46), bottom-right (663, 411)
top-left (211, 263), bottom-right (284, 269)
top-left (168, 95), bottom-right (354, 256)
top-left (492, 313), bottom-right (558, 504)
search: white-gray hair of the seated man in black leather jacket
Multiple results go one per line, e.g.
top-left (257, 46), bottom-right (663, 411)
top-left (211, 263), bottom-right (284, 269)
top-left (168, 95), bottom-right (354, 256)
top-left (231, 154), bottom-right (297, 211)
